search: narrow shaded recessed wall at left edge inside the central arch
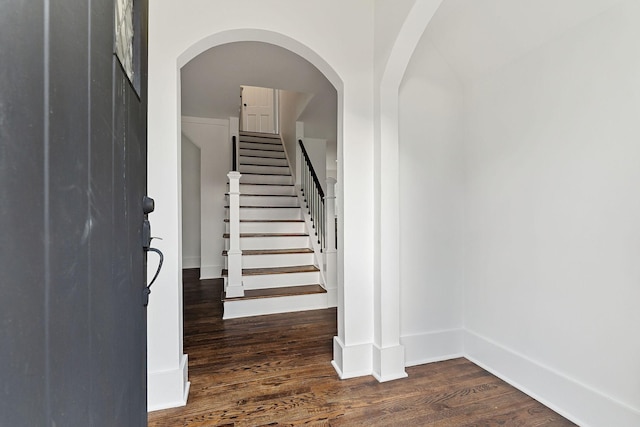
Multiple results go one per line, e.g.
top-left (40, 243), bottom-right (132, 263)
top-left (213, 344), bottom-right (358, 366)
top-left (181, 133), bottom-right (200, 268)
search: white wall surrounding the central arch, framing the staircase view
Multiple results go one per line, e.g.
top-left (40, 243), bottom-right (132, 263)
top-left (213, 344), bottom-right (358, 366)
top-left (148, 0), bottom-right (373, 408)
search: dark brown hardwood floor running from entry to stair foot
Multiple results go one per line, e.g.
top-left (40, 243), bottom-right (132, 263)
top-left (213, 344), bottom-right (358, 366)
top-left (149, 270), bottom-right (574, 427)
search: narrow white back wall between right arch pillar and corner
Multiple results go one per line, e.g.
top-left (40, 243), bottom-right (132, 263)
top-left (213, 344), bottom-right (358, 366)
top-left (399, 30), bottom-right (465, 365)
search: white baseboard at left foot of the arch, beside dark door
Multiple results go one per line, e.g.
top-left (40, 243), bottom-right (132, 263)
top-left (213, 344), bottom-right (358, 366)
top-left (147, 354), bottom-right (191, 412)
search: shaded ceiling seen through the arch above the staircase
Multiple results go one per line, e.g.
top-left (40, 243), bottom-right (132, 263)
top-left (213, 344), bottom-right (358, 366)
top-left (181, 42), bottom-right (337, 141)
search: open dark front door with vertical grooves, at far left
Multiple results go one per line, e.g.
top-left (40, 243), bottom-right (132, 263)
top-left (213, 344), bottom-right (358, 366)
top-left (0, 0), bottom-right (147, 427)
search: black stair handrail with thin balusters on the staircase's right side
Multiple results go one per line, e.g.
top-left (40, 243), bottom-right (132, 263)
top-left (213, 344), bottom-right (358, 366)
top-left (298, 139), bottom-right (326, 252)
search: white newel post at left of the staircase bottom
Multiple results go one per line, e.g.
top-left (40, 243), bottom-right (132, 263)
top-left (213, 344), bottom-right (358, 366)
top-left (226, 172), bottom-right (244, 298)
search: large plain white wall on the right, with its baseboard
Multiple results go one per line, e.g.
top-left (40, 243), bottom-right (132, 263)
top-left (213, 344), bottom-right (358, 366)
top-left (465, 1), bottom-right (640, 426)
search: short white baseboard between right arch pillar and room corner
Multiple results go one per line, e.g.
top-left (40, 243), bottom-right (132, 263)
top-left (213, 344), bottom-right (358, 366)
top-left (400, 329), bottom-right (464, 366)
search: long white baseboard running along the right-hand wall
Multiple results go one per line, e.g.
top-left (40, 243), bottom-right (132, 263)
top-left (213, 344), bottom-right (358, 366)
top-left (464, 330), bottom-right (640, 427)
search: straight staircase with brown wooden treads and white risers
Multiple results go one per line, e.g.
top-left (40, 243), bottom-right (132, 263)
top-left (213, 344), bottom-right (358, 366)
top-left (222, 132), bottom-right (328, 319)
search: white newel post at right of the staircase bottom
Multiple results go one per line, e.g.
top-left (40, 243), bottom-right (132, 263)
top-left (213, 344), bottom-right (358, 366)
top-left (324, 177), bottom-right (338, 307)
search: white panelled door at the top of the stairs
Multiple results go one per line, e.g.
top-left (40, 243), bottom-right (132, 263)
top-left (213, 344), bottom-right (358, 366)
top-left (242, 86), bottom-right (276, 133)
